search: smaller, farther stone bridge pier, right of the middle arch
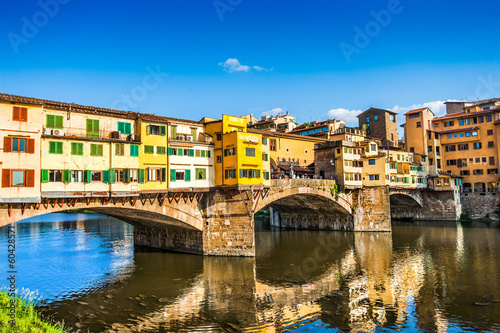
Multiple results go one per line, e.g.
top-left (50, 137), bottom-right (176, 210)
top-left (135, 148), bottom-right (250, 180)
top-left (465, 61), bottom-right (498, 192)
top-left (353, 186), bottom-right (391, 231)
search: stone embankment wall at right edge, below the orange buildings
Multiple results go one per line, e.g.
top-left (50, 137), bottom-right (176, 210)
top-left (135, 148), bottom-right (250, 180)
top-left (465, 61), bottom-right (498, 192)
top-left (461, 192), bottom-right (500, 219)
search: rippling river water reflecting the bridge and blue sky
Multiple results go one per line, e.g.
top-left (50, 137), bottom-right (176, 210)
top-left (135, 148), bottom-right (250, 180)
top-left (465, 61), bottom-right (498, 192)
top-left (0, 214), bottom-right (500, 332)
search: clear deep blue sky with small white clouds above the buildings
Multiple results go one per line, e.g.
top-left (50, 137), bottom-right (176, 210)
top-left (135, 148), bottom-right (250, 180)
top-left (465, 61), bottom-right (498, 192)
top-left (0, 0), bottom-right (500, 132)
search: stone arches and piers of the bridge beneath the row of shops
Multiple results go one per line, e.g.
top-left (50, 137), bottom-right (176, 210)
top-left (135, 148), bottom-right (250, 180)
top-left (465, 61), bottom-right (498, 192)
top-left (0, 179), bottom-right (459, 256)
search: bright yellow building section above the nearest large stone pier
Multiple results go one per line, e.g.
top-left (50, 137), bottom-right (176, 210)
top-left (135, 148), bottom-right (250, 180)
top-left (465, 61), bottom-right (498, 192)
top-left (201, 115), bottom-right (263, 187)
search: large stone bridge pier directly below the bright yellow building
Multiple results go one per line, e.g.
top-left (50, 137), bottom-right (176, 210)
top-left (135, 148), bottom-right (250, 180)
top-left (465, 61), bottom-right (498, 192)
top-left (203, 190), bottom-right (255, 256)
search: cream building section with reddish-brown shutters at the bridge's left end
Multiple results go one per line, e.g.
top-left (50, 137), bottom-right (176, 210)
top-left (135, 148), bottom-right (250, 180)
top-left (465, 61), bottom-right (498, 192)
top-left (0, 94), bottom-right (43, 203)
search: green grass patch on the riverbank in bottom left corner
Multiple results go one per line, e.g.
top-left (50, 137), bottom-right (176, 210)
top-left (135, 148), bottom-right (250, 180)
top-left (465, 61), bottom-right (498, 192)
top-left (0, 292), bottom-right (67, 333)
